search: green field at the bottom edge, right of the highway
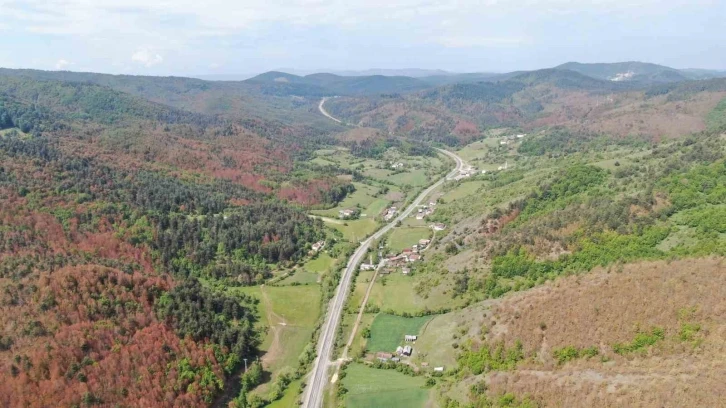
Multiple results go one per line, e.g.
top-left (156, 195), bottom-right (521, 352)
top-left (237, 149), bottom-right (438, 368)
top-left (343, 364), bottom-right (430, 408)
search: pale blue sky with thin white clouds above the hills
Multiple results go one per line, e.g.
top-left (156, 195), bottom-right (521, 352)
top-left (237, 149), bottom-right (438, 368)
top-left (0, 0), bottom-right (726, 76)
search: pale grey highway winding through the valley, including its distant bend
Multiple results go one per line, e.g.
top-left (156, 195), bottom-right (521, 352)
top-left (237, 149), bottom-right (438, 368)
top-left (303, 98), bottom-right (465, 408)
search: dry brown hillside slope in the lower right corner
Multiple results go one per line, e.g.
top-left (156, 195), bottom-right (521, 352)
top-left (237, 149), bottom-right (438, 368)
top-left (446, 258), bottom-right (726, 407)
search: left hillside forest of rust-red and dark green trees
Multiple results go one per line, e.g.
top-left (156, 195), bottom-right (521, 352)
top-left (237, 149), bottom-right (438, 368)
top-left (0, 75), bottom-right (351, 406)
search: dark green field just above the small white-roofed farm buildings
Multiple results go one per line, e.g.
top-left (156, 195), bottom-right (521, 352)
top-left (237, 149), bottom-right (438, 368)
top-left (367, 314), bottom-right (431, 352)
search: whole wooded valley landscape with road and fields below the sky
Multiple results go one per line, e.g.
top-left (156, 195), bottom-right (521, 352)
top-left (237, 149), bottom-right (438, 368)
top-left (0, 63), bottom-right (726, 408)
